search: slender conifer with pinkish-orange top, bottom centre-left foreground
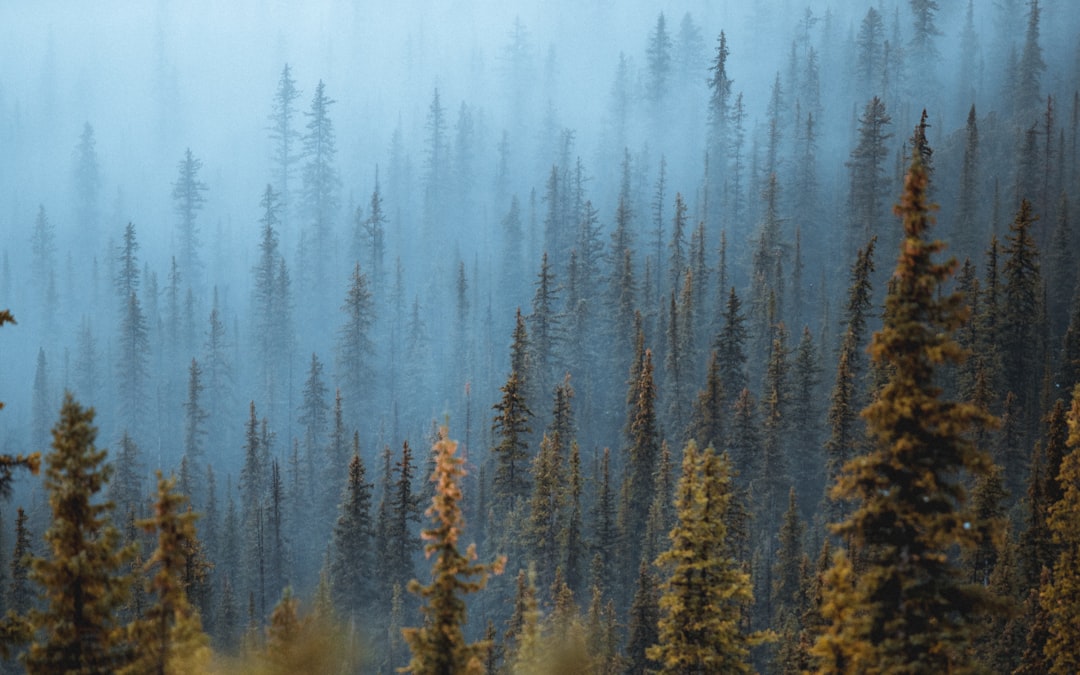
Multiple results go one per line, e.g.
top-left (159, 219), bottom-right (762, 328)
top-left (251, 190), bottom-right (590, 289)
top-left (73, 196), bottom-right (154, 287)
top-left (403, 428), bottom-right (505, 675)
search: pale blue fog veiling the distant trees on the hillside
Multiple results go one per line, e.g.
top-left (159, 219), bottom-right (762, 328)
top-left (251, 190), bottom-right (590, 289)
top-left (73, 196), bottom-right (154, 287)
top-left (0, 0), bottom-right (1080, 665)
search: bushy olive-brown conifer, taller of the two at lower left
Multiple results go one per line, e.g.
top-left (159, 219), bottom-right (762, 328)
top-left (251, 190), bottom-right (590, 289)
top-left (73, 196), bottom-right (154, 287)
top-left (25, 394), bottom-right (132, 674)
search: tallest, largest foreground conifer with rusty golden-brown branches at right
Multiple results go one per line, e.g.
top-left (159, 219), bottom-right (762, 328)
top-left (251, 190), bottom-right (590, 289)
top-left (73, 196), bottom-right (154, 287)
top-left (814, 154), bottom-right (989, 673)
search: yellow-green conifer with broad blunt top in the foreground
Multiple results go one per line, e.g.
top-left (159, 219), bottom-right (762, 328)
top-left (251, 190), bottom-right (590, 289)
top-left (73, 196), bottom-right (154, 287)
top-left (648, 441), bottom-right (765, 673)
